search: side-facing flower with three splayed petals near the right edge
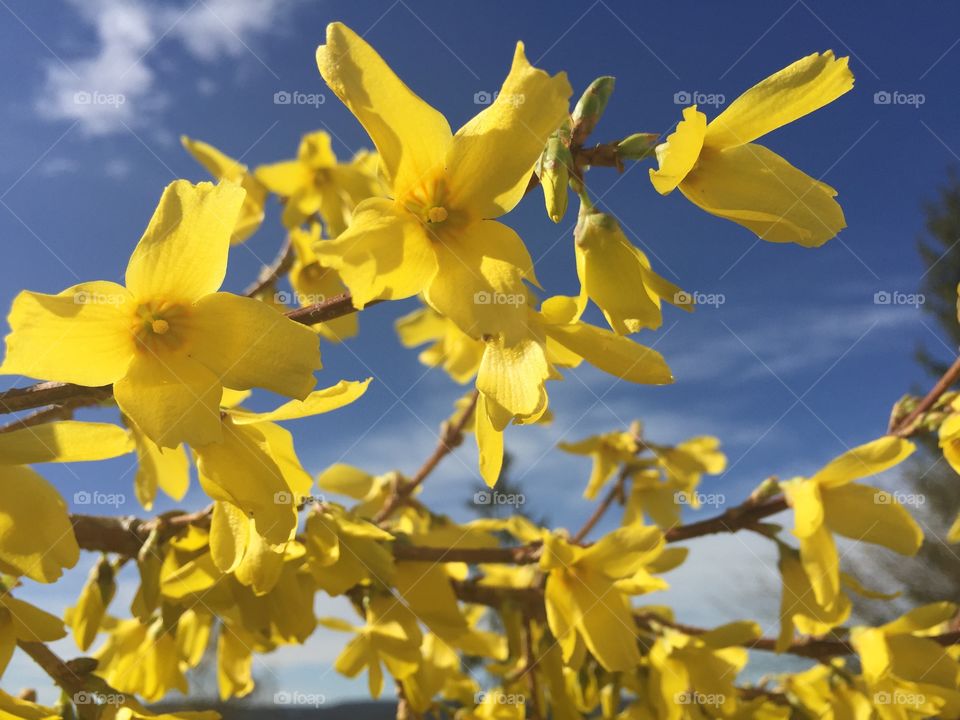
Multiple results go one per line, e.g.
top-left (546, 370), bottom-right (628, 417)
top-left (782, 437), bottom-right (923, 609)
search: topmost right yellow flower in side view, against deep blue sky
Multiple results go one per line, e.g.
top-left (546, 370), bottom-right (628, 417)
top-left (650, 50), bottom-right (853, 247)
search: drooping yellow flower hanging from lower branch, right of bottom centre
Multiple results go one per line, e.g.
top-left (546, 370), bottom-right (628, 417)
top-left (540, 525), bottom-right (665, 672)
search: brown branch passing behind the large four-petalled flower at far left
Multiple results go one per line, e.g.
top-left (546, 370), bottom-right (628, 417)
top-left (0, 293), bottom-right (372, 414)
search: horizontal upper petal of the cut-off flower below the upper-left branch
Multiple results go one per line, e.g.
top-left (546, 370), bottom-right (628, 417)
top-left (0, 420), bottom-right (133, 465)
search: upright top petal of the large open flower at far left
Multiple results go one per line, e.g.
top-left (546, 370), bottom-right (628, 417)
top-left (126, 180), bottom-right (246, 303)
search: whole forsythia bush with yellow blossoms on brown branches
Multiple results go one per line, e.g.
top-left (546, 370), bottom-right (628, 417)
top-left (0, 19), bottom-right (960, 720)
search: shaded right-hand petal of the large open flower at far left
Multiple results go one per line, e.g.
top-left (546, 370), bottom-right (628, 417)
top-left (188, 293), bottom-right (320, 401)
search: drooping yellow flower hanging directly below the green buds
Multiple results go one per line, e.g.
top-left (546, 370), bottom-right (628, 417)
top-left (574, 203), bottom-right (693, 335)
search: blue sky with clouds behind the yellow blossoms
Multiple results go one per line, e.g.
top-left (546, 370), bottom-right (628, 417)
top-left (0, 0), bottom-right (960, 701)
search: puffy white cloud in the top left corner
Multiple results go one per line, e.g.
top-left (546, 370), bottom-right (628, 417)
top-left (36, 0), bottom-right (297, 136)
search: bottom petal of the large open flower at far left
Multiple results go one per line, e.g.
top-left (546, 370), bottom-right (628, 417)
top-left (113, 353), bottom-right (222, 448)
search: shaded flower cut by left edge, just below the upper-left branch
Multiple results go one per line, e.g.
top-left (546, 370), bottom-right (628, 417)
top-left (0, 420), bottom-right (133, 583)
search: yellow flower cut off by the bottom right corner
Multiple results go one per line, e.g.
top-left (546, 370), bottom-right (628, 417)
top-left (850, 602), bottom-right (960, 720)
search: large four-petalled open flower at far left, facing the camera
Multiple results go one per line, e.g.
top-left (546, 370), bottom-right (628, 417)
top-left (0, 180), bottom-right (320, 448)
